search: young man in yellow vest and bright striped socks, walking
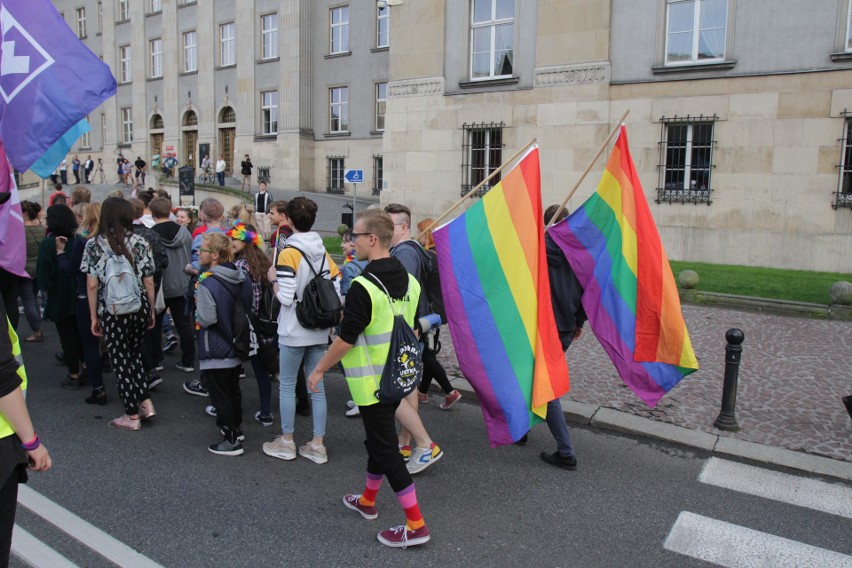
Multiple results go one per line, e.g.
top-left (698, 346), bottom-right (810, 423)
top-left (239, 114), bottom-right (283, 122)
top-left (308, 209), bottom-right (431, 548)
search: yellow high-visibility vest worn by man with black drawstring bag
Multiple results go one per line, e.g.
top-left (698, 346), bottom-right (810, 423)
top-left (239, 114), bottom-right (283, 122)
top-left (342, 274), bottom-right (420, 406)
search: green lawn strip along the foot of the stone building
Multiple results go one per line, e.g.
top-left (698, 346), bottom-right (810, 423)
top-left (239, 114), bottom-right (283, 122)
top-left (671, 260), bottom-right (852, 304)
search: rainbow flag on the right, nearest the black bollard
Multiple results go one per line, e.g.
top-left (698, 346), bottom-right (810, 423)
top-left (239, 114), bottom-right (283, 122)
top-left (549, 126), bottom-right (698, 407)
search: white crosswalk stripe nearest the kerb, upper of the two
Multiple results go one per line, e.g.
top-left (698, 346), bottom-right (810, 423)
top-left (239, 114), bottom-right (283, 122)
top-left (698, 458), bottom-right (852, 519)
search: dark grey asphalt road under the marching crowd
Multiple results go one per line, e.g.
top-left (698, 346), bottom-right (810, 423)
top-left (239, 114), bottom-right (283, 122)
top-left (12, 330), bottom-right (852, 568)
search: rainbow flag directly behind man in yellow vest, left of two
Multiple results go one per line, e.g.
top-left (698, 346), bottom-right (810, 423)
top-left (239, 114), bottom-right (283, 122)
top-left (433, 147), bottom-right (569, 447)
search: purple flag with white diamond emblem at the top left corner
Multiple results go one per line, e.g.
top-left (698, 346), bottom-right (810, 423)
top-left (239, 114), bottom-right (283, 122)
top-left (0, 0), bottom-right (115, 177)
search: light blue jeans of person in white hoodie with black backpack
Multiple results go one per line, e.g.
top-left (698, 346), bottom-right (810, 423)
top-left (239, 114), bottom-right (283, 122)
top-left (278, 344), bottom-right (328, 437)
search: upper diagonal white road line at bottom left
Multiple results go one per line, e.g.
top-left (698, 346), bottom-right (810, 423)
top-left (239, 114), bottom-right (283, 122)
top-left (18, 485), bottom-right (163, 568)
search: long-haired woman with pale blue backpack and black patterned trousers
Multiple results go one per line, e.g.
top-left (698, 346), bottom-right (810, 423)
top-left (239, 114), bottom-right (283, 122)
top-left (80, 197), bottom-right (156, 431)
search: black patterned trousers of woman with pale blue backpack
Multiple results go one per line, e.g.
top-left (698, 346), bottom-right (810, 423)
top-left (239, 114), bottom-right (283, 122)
top-left (101, 308), bottom-right (151, 415)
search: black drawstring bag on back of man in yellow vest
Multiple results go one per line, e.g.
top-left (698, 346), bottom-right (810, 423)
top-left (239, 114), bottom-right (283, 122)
top-left (367, 274), bottom-right (423, 403)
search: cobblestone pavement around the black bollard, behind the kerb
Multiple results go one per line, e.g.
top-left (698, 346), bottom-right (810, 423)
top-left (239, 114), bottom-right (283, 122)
top-left (441, 305), bottom-right (852, 461)
